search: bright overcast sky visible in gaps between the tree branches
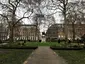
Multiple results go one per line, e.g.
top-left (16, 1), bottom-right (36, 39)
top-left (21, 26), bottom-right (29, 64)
top-left (0, 0), bottom-right (81, 32)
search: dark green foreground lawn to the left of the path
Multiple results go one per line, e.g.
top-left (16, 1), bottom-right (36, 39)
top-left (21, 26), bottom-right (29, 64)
top-left (0, 49), bottom-right (33, 64)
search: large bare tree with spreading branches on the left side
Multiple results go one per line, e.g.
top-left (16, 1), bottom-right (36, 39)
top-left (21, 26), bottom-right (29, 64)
top-left (0, 0), bottom-right (33, 42)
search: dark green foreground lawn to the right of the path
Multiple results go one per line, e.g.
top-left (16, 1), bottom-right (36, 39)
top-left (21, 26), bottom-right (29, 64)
top-left (55, 50), bottom-right (85, 64)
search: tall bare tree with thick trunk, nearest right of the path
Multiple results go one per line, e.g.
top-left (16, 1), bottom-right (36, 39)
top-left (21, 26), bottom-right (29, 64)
top-left (43, 0), bottom-right (68, 40)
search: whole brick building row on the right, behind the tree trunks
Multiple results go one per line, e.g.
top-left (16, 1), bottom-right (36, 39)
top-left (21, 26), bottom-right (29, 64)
top-left (46, 24), bottom-right (85, 41)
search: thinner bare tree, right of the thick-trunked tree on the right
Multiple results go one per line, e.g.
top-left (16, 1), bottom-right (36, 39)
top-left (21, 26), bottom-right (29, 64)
top-left (67, 3), bottom-right (78, 41)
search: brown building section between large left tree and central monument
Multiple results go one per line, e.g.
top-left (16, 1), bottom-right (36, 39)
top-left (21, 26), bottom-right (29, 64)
top-left (14, 25), bottom-right (40, 41)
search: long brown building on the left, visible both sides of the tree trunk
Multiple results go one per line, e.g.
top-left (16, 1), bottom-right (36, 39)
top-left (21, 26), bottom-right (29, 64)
top-left (0, 23), bottom-right (40, 41)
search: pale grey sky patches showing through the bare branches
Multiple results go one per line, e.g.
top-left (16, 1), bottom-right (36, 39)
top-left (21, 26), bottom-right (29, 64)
top-left (0, 0), bottom-right (81, 31)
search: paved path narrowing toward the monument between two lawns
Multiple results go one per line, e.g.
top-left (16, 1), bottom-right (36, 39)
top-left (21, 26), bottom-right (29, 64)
top-left (23, 47), bottom-right (67, 64)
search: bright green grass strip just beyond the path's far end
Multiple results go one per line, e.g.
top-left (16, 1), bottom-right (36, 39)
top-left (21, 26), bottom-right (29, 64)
top-left (25, 42), bottom-right (61, 46)
